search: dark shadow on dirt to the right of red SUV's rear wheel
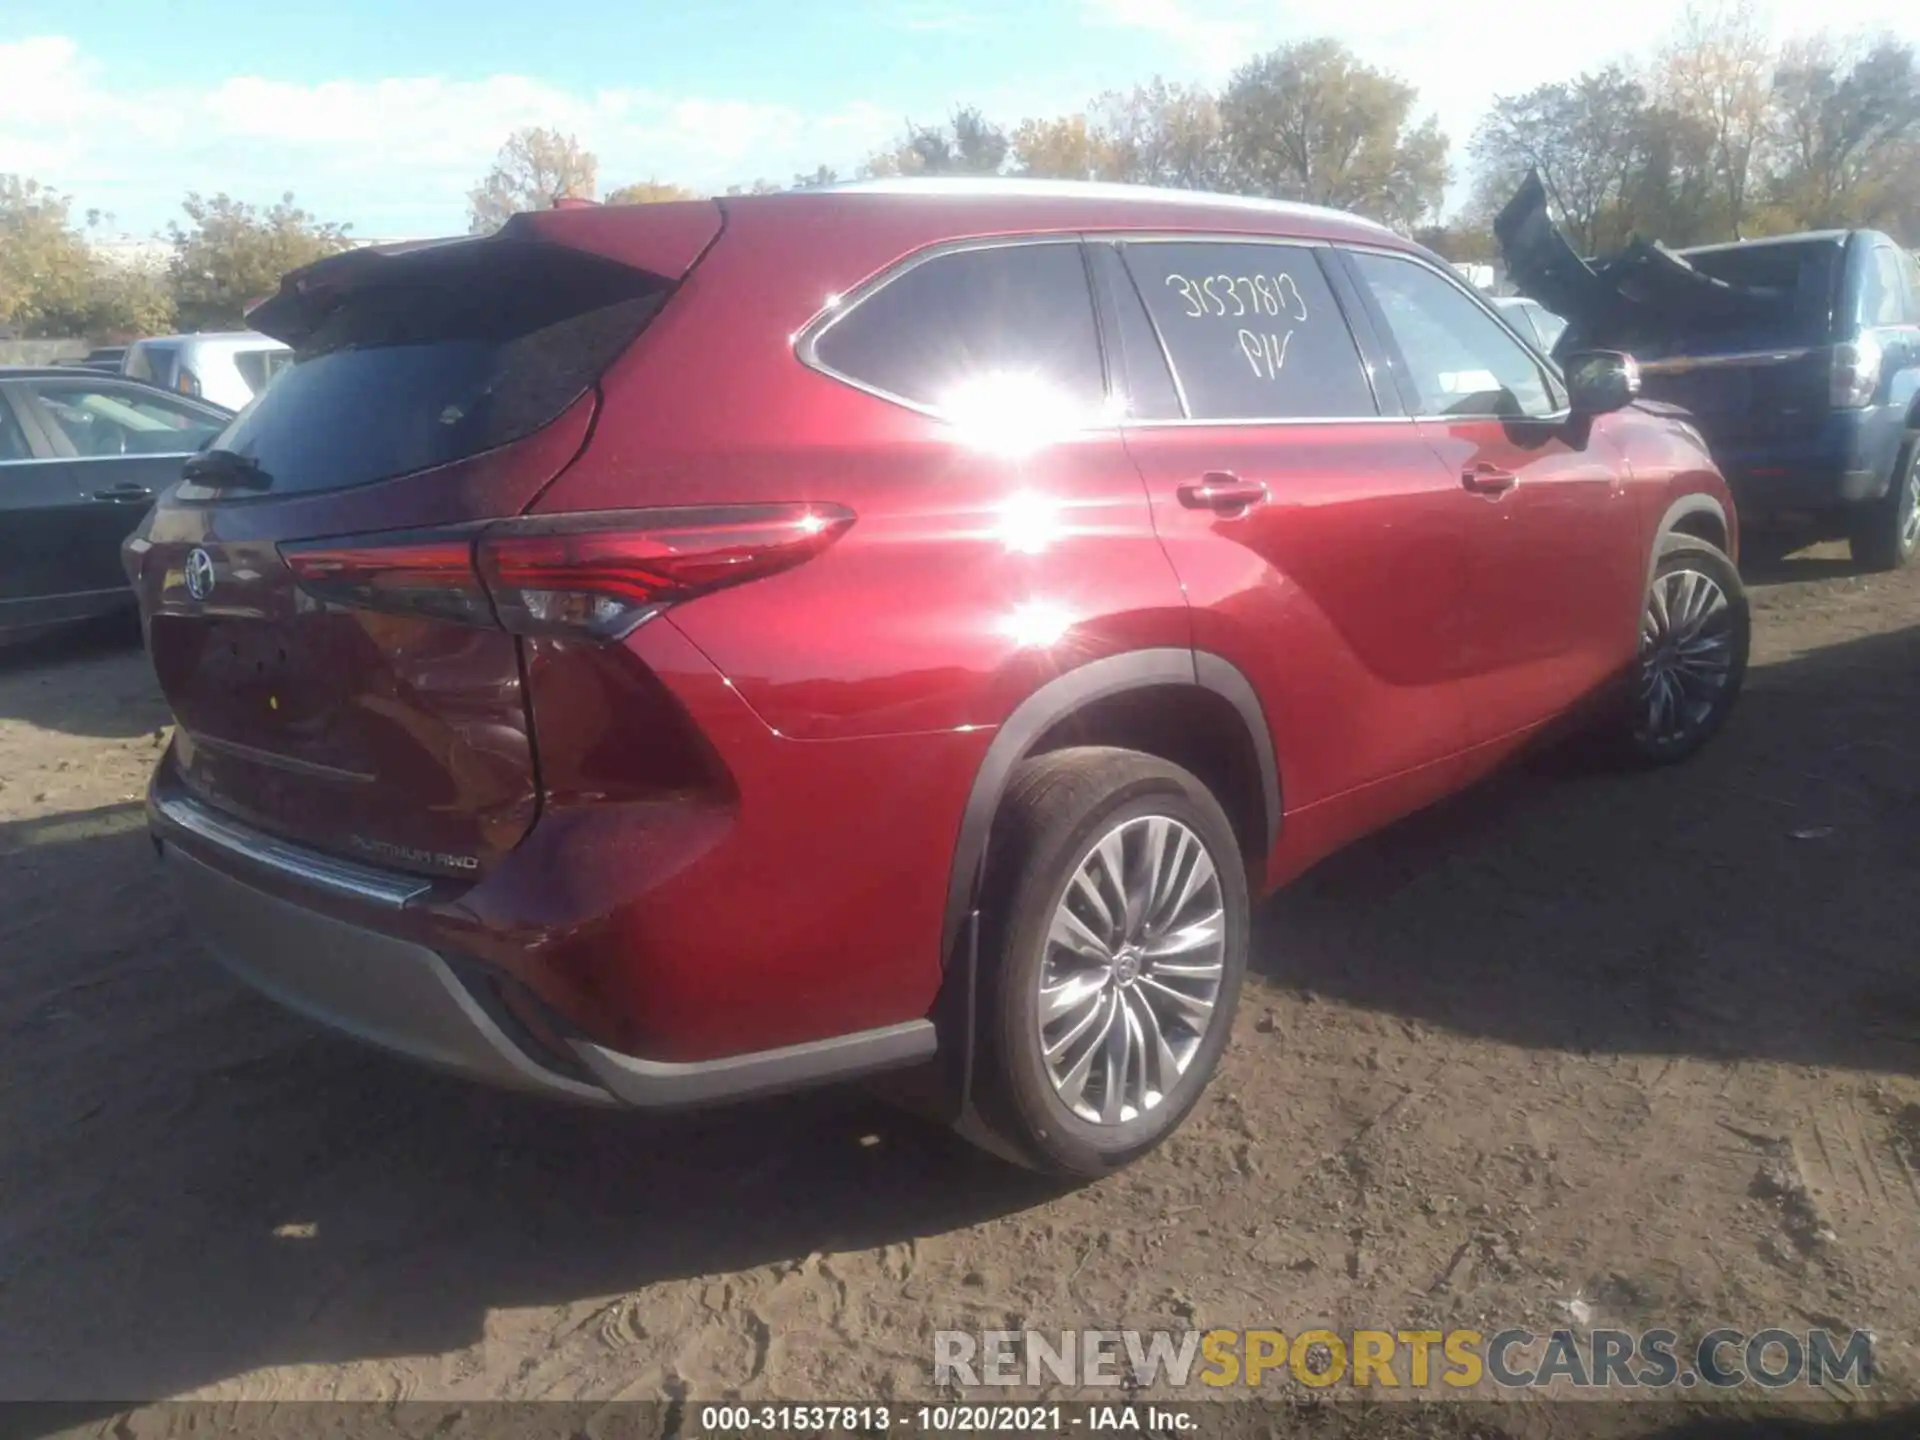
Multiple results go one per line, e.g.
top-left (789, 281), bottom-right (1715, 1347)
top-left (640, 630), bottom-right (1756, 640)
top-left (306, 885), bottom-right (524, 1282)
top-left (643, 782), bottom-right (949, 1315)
top-left (1254, 628), bottom-right (1920, 1073)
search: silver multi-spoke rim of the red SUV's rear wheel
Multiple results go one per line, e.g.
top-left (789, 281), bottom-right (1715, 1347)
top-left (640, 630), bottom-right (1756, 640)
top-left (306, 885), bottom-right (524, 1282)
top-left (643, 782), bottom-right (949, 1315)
top-left (1039, 816), bottom-right (1227, 1125)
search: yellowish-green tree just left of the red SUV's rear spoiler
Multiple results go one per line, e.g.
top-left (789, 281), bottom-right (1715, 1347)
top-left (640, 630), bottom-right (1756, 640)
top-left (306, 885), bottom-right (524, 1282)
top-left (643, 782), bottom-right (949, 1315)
top-left (167, 192), bottom-right (351, 330)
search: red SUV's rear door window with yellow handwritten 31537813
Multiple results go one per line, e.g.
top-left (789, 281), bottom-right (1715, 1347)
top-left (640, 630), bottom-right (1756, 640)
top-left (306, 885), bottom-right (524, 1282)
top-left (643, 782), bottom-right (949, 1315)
top-left (1125, 242), bottom-right (1379, 420)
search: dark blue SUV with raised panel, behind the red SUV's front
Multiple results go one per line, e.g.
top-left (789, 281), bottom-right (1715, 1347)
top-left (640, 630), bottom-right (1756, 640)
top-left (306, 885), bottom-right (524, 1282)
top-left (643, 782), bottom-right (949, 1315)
top-left (1496, 179), bottom-right (1920, 570)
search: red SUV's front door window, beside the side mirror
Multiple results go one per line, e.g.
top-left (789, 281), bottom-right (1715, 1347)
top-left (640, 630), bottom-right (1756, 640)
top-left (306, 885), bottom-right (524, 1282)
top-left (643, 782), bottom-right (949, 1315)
top-left (1352, 250), bottom-right (1559, 419)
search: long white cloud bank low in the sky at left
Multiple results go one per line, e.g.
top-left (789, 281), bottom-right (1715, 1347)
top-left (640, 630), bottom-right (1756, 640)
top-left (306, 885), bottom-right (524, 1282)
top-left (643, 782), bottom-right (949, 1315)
top-left (0, 36), bottom-right (899, 236)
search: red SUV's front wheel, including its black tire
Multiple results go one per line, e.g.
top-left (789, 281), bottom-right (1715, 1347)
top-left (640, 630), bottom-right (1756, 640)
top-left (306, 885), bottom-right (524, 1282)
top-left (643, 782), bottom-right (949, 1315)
top-left (1615, 536), bottom-right (1753, 766)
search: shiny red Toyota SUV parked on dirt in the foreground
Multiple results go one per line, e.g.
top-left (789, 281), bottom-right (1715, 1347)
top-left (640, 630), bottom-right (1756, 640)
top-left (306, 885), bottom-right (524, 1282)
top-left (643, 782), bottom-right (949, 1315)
top-left (125, 182), bottom-right (1747, 1173)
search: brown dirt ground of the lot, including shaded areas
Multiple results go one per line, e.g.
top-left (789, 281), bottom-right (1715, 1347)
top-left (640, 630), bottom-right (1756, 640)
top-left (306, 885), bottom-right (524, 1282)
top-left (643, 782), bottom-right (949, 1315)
top-left (0, 549), bottom-right (1920, 1434)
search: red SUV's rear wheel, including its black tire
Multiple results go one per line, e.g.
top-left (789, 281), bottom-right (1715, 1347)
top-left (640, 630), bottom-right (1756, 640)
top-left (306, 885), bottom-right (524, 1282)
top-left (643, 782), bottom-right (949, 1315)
top-left (973, 747), bottom-right (1248, 1177)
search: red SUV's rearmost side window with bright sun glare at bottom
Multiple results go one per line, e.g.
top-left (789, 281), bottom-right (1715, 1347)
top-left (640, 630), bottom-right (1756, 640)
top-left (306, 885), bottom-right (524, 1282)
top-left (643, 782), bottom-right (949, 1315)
top-left (812, 244), bottom-right (1106, 415)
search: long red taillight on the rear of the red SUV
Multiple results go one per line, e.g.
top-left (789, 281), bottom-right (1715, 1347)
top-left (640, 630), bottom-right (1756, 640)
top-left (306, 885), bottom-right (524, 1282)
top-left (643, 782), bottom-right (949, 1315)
top-left (280, 505), bottom-right (854, 639)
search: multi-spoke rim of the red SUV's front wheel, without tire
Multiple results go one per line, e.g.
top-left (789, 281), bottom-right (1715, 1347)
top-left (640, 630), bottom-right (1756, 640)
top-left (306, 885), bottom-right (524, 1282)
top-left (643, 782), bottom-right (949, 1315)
top-left (1634, 570), bottom-right (1734, 747)
